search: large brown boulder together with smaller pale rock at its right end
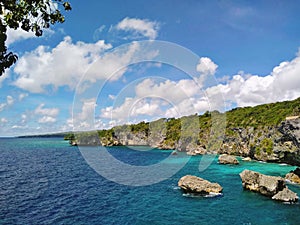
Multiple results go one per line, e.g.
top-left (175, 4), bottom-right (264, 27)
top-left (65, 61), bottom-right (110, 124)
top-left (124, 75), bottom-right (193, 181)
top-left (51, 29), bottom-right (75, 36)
top-left (240, 170), bottom-right (298, 202)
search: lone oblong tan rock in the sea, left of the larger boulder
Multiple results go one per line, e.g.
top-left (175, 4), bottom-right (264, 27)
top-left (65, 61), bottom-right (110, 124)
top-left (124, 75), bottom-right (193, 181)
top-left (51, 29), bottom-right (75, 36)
top-left (178, 175), bottom-right (223, 194)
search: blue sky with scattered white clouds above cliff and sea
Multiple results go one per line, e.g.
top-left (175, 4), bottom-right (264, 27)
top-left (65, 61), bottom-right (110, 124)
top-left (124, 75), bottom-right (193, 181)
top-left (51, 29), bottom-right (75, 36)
top-left (0, 0), bottom-right (300, 136)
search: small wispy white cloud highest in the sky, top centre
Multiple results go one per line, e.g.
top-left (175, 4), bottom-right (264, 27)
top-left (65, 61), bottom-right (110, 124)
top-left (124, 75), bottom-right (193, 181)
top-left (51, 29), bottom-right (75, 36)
top-left (115, 17), bottom-right (160, 40)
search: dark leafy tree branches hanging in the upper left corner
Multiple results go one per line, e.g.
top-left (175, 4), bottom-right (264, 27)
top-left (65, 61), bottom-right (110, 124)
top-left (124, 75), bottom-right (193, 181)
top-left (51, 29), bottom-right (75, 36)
top-left (0, 0), bottom-right (72, 76)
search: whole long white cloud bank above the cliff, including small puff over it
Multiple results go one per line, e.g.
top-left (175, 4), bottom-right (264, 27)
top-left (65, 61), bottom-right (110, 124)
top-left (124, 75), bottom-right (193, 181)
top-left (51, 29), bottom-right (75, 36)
top-left (97, 50), bottom-right (300, 128)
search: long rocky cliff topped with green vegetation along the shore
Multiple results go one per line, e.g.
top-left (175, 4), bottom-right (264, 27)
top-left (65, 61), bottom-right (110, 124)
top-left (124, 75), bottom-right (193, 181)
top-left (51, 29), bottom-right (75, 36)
top-left (65, 98), bottom-right (300, 166)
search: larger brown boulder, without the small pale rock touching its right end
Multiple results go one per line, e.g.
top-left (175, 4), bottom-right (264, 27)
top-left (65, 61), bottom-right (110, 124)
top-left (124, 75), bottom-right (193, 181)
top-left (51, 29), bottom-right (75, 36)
top-left (240, 170), bottom-right (285, 196)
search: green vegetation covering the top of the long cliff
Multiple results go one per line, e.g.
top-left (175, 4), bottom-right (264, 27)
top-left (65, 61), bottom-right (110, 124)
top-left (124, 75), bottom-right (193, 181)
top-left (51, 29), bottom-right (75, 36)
top-left (65, 98), bottom-right (300, 149)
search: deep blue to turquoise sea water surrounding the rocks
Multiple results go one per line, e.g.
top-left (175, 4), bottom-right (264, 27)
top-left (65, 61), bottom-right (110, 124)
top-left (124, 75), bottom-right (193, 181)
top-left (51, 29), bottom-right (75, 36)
top-left (0, 138), bottom-right (300, 225)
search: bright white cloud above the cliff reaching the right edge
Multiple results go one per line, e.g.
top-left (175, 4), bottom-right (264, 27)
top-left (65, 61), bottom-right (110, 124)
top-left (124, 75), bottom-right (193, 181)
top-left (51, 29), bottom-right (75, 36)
top-left (207, 51), bottom-right (300, 107)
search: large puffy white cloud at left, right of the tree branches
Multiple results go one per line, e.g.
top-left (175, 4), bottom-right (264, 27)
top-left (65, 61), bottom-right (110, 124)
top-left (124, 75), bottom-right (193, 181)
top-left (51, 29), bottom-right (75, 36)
top-left (13, 37), bottom-right (157, 93)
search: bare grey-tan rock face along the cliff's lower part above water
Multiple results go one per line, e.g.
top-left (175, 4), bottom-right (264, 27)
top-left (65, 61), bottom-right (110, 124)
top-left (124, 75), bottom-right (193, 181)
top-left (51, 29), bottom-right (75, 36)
top-left (70, 118), bottom-right (300, 166)
